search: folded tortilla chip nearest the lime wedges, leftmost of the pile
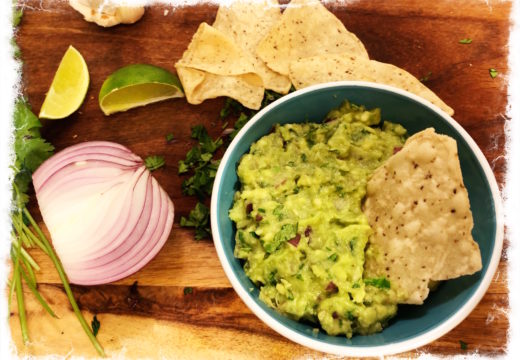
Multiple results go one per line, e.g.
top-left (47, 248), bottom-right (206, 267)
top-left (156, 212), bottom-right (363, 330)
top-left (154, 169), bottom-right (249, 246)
top-left (175, 23), bottom-right (264, 110)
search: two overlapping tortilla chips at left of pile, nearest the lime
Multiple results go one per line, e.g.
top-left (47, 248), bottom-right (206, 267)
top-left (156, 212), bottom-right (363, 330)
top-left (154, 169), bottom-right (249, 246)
top-left (175, 0), bottom-right (291, 109)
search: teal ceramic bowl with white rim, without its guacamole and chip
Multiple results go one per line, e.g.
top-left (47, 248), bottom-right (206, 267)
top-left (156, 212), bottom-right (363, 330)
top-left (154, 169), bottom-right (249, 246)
top-left (211, 82), bottom-right (503, 356)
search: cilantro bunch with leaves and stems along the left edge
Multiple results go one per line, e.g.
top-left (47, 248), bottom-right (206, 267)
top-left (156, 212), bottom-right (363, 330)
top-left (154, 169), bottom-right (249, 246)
top-left (8, 23), bottom-right (105, 356)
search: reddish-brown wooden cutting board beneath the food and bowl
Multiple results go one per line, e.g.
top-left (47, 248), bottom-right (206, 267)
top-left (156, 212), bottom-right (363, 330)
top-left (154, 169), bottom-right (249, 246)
top-left (10, 0), bottom-right (511, 359)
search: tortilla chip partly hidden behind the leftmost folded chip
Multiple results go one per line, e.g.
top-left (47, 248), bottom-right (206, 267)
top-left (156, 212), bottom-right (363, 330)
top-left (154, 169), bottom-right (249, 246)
top-left (213, 0), bottom-right (291, 94)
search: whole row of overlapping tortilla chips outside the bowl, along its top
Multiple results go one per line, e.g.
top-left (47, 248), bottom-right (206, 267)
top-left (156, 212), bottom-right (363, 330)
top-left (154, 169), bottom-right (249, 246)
top-left (175, 0), bottom-right (453, 115)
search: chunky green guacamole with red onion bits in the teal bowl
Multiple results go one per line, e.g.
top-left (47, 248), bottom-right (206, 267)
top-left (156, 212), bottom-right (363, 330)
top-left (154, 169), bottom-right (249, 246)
top-left (229, 102), bottom-right (406, 337)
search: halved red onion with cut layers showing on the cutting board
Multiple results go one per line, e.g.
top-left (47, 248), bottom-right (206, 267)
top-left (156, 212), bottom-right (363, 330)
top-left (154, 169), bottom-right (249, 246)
top-left (33, 141), bottom-right (174, 285)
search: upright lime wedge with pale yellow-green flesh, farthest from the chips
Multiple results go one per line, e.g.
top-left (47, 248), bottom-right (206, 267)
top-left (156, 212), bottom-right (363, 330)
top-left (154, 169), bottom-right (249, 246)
top-left (39, 46), bottom-right (90, 119)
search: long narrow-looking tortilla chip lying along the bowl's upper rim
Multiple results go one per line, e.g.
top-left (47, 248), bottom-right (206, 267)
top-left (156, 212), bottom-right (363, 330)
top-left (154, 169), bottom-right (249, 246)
top-left (289, 54), bottom-right (454, 115)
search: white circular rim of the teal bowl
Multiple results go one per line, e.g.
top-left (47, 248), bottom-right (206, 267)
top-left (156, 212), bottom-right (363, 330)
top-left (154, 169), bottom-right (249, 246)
top-left (210, 81), bottom-right (504, 357)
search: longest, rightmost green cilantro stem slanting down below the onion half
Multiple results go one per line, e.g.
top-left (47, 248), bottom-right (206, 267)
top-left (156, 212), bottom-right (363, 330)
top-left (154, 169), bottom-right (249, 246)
top-left (23, 208), bottom-right (105, 357)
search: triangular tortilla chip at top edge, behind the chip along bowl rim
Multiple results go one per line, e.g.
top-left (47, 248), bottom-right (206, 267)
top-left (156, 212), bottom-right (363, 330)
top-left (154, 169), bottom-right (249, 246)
top-left (256, 0), bottom-right (368, 75)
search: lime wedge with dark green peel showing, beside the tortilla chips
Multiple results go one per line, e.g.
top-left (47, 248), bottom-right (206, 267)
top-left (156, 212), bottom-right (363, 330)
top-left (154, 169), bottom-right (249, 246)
top-left (99, 64), bottom-right (184, 115)
